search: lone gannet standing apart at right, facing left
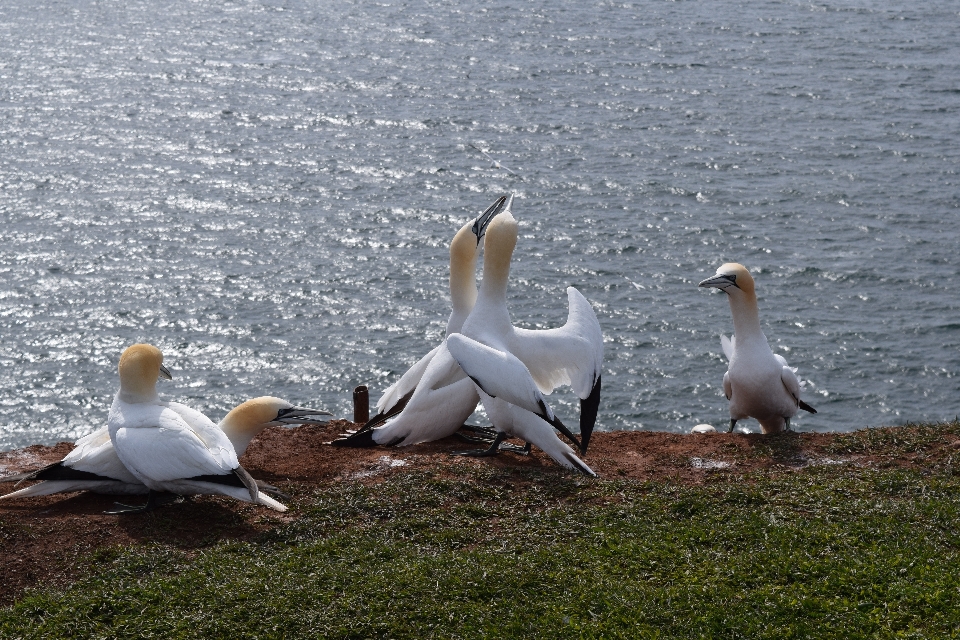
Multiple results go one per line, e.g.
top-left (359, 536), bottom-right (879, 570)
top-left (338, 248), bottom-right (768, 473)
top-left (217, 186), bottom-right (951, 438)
top-left (700, 262), bottom-right (817, 433)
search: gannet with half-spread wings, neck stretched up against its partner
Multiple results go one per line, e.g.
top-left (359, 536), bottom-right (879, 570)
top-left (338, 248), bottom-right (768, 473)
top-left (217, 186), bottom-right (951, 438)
top-left (447, 198), bottom-right (603, 475)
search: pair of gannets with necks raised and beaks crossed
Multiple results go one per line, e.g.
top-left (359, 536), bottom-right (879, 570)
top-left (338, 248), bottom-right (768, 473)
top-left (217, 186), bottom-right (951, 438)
top-left (333, 196), bottom-right (603, 475)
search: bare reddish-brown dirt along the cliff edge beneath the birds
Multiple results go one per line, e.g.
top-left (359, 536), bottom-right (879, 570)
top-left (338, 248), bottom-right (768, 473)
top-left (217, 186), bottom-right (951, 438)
top-left (0, 420), bottom-right (960, 605)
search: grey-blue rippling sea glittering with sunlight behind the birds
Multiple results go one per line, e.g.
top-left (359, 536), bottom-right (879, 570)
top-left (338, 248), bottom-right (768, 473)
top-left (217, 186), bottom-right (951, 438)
top-left (0, 0), bottom-right (960, 449)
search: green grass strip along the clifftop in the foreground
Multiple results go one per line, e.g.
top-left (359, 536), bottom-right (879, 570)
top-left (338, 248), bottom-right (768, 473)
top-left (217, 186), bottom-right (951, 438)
top-left (0, 463), bottom-right (960, 639)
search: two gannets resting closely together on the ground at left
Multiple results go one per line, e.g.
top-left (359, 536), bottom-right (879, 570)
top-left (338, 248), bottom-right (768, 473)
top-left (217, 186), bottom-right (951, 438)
top-left (0, 344), bottom-right (332, 513)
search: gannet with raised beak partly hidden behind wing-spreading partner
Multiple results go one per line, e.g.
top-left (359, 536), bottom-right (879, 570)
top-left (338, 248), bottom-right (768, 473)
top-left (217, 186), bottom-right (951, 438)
top-left (332, 196), bottom-right (507, 447)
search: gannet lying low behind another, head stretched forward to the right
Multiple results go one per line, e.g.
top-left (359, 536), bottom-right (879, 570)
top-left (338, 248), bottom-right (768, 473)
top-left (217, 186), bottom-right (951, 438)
top-left (0, 392), bottom-right (332, 500)
